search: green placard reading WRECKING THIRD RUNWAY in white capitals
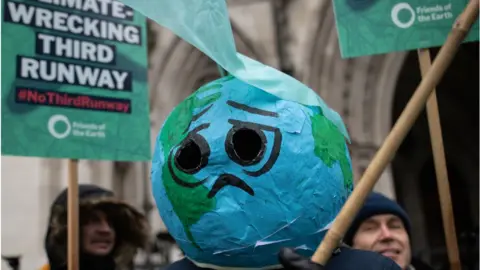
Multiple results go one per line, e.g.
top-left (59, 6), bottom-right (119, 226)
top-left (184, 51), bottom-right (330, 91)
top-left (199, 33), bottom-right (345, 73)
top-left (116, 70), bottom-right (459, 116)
top-left (2, 0), bottom-right (151, 161)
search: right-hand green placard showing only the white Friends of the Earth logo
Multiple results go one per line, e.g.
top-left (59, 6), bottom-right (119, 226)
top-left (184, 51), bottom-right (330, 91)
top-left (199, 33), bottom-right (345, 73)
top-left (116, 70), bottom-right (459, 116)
top-left (332, 0), bottom-right (479, 58)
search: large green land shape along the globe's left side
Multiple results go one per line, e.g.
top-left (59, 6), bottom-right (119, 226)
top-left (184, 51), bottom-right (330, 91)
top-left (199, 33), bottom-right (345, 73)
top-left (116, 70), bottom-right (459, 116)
top-left (160, 76), bottom-right (233, 248)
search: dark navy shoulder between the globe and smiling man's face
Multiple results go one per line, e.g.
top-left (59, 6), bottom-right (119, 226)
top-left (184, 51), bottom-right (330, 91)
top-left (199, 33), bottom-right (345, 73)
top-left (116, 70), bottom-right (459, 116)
top-left (325, 247), bottom-right (401, 270)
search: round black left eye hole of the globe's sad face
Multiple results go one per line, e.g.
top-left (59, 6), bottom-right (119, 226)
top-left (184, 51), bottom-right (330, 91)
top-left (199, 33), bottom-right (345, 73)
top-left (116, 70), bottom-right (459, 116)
top-left (174, 134), bottom-right (210, 174)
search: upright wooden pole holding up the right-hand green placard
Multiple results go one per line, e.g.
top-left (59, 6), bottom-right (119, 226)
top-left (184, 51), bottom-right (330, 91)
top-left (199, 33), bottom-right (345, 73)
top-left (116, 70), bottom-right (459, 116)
top-left (418, 49), bottom-right (461, 270)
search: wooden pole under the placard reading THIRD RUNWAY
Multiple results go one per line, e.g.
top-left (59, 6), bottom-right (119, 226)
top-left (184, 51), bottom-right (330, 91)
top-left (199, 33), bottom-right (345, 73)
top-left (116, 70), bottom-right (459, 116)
top-left (67, 159), bottom-right (79, 270)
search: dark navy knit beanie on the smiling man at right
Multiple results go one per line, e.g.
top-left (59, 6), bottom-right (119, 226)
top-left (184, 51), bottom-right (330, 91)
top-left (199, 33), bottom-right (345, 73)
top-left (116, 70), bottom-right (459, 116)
top-left (343, 192), bottom-right (411, 246)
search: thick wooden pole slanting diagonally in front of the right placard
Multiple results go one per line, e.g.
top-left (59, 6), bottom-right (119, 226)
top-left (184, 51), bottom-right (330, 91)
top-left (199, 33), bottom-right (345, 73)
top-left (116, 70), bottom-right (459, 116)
top-left (312, 0), bottom-right (479, 265)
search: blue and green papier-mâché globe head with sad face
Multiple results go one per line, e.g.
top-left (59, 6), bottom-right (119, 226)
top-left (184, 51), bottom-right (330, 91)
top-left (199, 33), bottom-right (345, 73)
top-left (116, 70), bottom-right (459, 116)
top-left (152, 76), bottom-right (352, 268)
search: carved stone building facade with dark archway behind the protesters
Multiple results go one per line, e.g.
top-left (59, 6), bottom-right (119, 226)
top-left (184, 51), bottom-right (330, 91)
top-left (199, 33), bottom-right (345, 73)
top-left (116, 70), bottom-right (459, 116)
top-left (2, 0), bottom-right (479, 269)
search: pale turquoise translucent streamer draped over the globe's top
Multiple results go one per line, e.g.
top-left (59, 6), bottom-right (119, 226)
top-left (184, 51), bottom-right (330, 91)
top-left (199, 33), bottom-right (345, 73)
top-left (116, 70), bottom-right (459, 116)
top-left (116, 0), bottom-right (350, 141)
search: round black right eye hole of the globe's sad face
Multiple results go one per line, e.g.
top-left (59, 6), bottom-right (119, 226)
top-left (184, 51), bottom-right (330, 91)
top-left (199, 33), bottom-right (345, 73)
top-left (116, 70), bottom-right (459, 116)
top-left (225, 126), bottom-right (267, 166)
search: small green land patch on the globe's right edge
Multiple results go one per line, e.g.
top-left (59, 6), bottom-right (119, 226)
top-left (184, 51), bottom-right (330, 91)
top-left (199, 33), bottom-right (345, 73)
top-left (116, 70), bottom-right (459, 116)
top-left (310, 109), bottom-right (353, 190)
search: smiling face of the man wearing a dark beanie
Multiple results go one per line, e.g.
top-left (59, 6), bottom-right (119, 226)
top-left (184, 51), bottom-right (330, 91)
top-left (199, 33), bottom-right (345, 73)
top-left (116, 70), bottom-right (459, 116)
top-left (353, 214), bottom-right (411, 269)
